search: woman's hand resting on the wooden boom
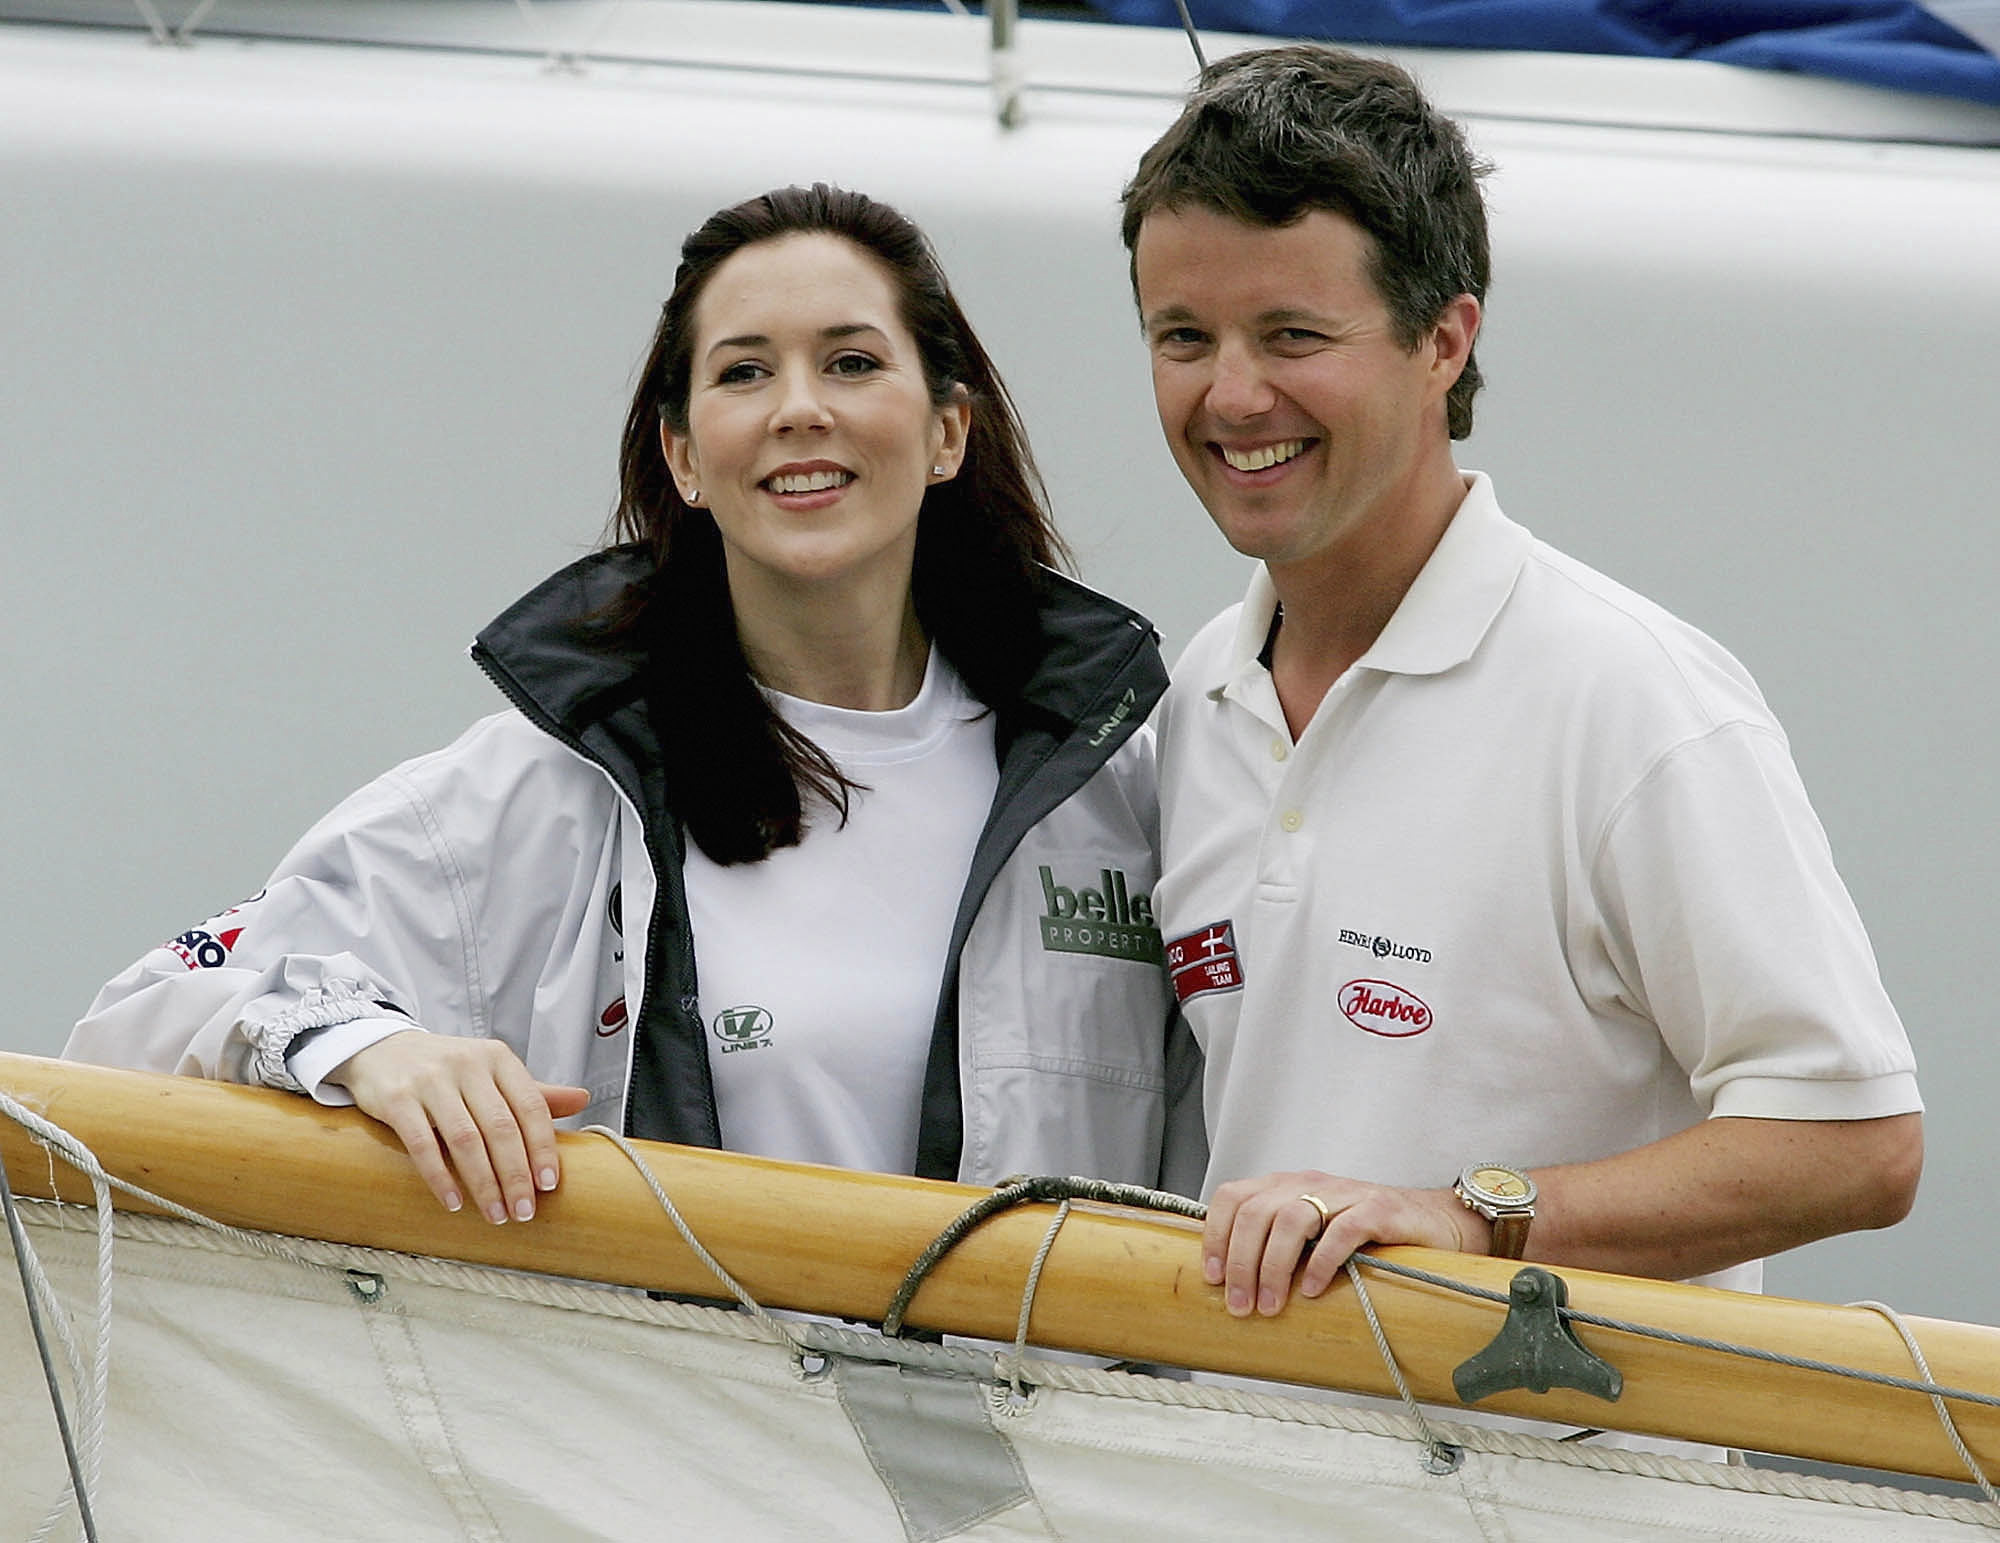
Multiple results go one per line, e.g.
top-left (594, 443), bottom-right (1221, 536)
top-left (328, 1029), bottom-right (590, 1223)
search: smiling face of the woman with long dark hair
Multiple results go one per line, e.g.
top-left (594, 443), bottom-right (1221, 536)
top-left (662, 234), bottom-right (972, 610)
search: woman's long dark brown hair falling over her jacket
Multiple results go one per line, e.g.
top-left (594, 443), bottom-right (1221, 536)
top-left (612, 182), bottom-right (1068, 863)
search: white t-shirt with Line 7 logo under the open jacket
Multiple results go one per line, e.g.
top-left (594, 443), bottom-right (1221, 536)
top-left (686, 650), bottom-right (998, 1173)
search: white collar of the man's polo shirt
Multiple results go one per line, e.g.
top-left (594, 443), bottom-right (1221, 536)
top-left (1208, 472), bottom-right (1530, 696)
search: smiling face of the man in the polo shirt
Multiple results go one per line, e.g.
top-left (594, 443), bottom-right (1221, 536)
top-left (1136, 208), bottom-right (1478, 579)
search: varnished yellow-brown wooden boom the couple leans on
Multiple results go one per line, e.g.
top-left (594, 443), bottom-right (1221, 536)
top-left (0, 1053), bottom-right (2000, 1479)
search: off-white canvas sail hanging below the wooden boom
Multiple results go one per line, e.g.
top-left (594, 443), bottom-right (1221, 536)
top-left (0, 1203), bottom-right (1992, 1543)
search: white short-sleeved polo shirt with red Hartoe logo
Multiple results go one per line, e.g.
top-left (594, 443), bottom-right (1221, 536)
top-left (1156, 474), bottom-right (1922, 1289)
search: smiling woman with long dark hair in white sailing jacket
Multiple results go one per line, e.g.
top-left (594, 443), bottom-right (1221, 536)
top-left (66, 186), bottom-right (1200, 1223)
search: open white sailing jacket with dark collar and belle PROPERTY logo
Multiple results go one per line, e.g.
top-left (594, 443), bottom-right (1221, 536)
top-left (64, 548), bottom-right (1206, 1193)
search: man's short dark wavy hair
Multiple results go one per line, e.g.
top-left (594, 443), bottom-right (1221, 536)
top-left (1122, 44), bottom-right (1492, 440)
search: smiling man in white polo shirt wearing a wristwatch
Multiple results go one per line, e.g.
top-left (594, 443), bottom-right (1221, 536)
top-left (1124, 46), bottom-right (1922, 1313)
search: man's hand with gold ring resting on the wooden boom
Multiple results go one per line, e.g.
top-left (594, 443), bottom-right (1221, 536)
top-left (1202, 1169), bottom-right (1488, 1317)
